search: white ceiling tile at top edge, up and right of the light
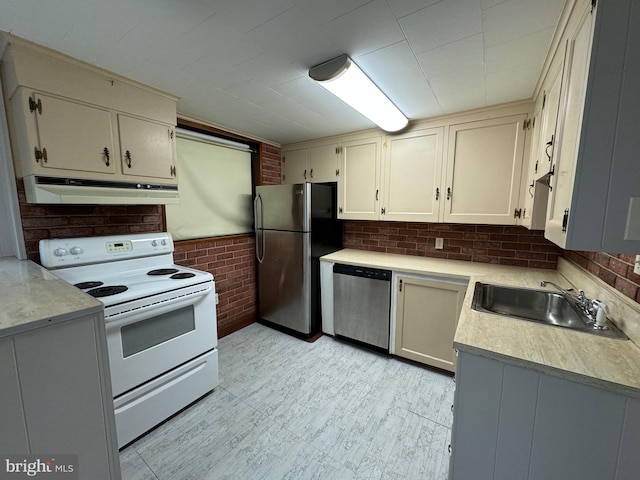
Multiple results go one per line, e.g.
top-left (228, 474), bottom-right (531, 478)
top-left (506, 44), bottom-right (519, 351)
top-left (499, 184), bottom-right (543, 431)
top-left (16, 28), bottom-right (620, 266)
top-left (400, 0), bottom-right (482, 53)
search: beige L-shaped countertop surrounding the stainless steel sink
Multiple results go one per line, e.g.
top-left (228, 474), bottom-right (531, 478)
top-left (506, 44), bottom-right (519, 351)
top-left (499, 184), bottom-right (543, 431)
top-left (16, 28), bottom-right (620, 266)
top-left (321, 249), bottom-right (640, 398)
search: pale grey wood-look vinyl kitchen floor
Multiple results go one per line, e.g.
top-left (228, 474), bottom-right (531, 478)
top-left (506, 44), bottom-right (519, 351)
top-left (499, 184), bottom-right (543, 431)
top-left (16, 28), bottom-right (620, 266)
top-left (120, 324), bottom-right (454, 480)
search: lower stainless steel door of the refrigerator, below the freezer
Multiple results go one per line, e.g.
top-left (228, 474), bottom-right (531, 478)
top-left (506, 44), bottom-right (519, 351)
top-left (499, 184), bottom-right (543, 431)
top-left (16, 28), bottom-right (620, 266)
top-left (258, 230), bottom-right (311, 335)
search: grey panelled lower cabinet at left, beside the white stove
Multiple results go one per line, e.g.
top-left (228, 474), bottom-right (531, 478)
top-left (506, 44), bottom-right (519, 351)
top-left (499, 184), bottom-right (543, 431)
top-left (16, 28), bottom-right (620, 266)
top-left (0, 313), bottom-right (120, 480)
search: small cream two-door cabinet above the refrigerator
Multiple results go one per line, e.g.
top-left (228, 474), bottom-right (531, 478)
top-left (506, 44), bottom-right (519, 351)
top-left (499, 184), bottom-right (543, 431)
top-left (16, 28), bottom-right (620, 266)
top-left (282, 142), bottom-right (339, 183)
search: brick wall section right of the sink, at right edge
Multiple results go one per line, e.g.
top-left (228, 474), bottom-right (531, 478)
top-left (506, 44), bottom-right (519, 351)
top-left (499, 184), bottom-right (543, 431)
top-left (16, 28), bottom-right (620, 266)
top-left (564, 250), bottom-right (640, 303)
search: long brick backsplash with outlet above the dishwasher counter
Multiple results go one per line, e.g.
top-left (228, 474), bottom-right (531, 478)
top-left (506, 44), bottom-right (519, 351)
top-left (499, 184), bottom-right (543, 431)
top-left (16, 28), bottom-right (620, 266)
top-left (344, 221), bottom-right (562, 269)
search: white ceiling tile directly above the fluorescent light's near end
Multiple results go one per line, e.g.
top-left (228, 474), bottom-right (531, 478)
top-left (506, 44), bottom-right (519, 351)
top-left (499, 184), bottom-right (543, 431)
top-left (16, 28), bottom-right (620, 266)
top-left (321, 0), bottom-right (405, 56)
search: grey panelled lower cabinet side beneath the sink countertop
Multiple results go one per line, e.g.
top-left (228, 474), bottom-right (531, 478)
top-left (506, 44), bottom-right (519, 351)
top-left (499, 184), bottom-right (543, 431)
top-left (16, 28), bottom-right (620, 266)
top-left (449, 351), bottom-right (640, 480)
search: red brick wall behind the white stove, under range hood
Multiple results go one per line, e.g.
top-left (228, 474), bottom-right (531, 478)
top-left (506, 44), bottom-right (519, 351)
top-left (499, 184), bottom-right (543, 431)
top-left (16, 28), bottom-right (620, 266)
top-left (17, 180), bottom-right (166, 263)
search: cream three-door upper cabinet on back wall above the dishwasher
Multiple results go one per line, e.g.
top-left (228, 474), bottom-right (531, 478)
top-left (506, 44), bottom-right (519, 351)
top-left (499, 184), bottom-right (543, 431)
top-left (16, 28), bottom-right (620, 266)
top-left (314, 104), bottom-right (531, 225)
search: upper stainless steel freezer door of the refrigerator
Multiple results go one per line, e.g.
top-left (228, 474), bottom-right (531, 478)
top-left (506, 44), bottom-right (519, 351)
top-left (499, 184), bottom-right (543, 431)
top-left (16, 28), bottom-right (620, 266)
top-left (254, 183), bottom-right (311, 232)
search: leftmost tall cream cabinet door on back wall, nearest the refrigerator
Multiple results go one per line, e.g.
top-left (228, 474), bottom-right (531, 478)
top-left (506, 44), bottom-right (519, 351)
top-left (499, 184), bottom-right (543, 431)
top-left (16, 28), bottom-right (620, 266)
top-left (338, 137), bottom-right (382, 220)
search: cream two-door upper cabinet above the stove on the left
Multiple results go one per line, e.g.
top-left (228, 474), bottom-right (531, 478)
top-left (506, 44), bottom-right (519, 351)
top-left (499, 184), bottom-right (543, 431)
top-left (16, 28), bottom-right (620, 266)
top-left (0, 35), bottom-right (178, 203)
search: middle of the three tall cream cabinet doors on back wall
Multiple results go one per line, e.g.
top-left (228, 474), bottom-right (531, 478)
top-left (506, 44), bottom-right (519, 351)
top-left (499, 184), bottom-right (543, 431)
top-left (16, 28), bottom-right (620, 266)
top-left (381, 128), bottom-right (444, 222)
